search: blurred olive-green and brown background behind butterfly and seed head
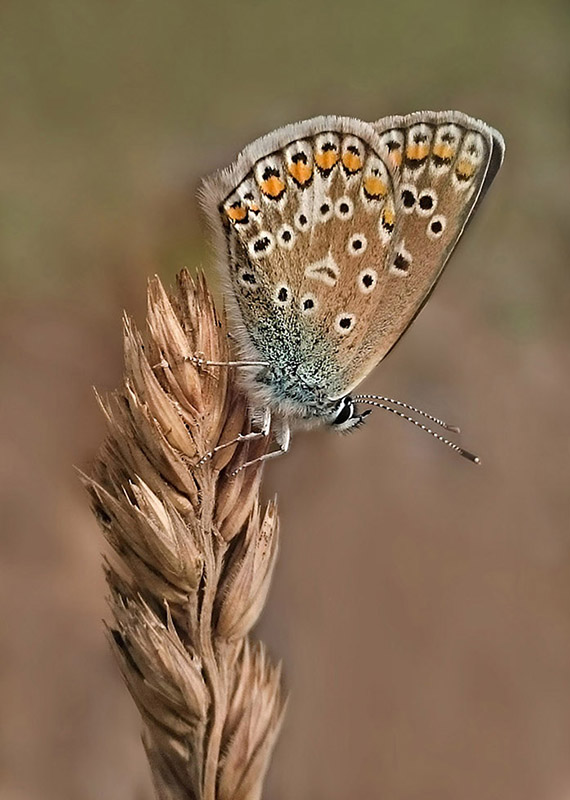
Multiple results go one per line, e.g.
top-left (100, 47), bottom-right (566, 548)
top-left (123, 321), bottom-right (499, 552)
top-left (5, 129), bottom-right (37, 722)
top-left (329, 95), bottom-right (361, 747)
top-left (0, 0), bottom-right (570, 800)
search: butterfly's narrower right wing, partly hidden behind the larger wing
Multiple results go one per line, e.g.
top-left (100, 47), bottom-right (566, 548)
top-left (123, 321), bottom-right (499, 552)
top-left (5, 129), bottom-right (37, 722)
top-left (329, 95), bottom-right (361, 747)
top-left (351, 111), bottom-right (505, 383)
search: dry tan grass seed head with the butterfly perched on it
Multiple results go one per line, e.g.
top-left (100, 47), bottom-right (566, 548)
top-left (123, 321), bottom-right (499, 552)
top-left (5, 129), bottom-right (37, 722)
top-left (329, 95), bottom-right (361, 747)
top-left (85, 272), bottom-right (283, 800)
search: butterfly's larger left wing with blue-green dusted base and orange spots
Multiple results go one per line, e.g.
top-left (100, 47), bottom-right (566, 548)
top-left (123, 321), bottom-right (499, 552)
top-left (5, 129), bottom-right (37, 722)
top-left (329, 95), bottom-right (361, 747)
top-left (200, 117), bottom-right (398, 405)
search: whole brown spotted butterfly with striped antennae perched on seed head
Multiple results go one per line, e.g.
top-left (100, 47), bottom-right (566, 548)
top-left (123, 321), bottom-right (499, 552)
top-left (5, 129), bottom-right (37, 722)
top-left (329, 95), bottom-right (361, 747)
top-left (202, 111), bottom-right (505, 467)
